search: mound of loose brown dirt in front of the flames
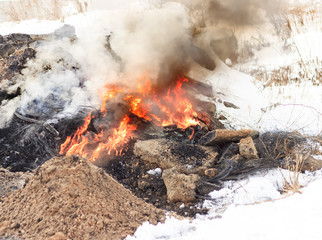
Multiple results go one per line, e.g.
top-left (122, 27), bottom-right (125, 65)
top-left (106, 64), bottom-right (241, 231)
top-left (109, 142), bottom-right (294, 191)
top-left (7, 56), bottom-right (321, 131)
top-left (0, 157), bottom-right (164, 239)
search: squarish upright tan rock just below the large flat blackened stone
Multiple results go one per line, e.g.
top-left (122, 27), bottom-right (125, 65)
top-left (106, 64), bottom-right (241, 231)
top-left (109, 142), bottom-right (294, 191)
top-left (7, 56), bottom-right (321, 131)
top-left (162, 167), bottom-right (200, 203)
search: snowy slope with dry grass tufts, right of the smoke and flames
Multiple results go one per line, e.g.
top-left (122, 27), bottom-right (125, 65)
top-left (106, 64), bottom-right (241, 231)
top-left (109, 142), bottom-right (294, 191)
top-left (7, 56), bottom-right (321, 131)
top-left (196, 4), bottom-right (322, 135)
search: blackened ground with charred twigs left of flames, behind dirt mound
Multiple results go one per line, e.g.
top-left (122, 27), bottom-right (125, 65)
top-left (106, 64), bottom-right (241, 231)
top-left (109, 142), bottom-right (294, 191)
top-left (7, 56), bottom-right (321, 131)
top-left (0, 113), bottom-right (92, 172)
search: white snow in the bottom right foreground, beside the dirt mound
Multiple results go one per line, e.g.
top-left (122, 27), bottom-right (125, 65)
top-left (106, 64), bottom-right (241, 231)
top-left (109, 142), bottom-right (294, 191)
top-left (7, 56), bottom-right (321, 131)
top-left (127, 171), bottom-right (322, 240)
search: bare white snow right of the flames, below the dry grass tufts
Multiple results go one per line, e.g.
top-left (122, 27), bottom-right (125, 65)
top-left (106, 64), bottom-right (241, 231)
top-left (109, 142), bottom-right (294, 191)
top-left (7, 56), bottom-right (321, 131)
top-left (210, 70), bottom-right (322, 135)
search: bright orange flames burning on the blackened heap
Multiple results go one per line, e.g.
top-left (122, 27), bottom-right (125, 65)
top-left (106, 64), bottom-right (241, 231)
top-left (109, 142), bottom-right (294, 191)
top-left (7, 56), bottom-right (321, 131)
top-left (60, 76), bottom-right (199, 161)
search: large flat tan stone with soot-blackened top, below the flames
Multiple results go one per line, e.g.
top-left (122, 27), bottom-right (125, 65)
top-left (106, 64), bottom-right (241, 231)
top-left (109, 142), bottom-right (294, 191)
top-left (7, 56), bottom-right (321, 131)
top-left (134, 139), bottom-right (218, 170)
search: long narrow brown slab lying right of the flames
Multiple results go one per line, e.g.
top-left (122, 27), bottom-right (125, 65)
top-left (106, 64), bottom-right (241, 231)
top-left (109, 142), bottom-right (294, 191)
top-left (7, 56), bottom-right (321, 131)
top-left (199, 129), bottom-right (258, 146)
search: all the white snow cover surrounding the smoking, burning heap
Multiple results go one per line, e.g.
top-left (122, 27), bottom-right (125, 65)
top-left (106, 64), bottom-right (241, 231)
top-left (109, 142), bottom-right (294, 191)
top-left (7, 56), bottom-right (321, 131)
top-left (0, 1), bottom-right (322, 240)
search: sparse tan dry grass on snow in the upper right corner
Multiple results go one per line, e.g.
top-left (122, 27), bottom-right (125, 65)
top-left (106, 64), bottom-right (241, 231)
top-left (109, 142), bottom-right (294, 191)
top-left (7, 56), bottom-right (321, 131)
top-left (254, 4), bottom-right (322, 86)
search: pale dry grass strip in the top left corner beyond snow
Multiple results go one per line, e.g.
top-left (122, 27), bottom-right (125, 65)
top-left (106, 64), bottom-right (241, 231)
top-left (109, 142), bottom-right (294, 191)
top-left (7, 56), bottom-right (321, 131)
top-left (0, 0), bottom-right (88, 21)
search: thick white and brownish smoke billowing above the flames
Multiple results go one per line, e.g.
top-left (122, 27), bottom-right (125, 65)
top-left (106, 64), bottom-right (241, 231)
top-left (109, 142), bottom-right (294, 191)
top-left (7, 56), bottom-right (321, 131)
top-left (0, 0), bottom-right (284, 126)
